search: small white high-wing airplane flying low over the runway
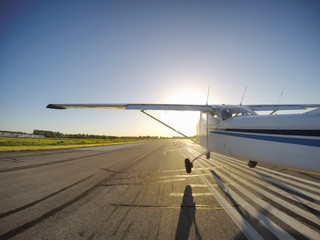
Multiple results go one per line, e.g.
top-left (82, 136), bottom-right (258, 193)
top-left (47, 104), bottom-right (320, 173)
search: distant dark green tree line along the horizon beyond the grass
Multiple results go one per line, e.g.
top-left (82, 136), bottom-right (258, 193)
top-left (33, 130), bottom-right (162, 139)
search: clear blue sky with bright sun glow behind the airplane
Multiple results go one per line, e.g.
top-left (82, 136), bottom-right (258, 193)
top-left (0, 0), bottom-right (320, 135)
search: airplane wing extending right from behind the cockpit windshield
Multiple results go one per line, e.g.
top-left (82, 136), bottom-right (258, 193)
top-left (246, 104), bottom-right (320, 111)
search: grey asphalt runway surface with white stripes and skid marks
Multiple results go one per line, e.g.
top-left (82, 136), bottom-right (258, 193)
top-left (0, 140), bottom-right (320, 240)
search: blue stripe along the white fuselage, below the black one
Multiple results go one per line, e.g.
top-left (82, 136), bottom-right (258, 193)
top-left (210, 131), bottom-right (320, 147)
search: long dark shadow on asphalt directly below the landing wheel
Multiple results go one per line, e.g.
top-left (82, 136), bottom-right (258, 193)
top-left (175, 185), bottom-right (201, 240)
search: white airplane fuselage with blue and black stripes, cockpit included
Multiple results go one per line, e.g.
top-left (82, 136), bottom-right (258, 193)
top-left (197, 106), bottom-right (320, 172)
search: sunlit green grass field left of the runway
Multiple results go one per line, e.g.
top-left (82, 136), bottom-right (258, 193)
top-left (0, 137), bottom-right (149, 152)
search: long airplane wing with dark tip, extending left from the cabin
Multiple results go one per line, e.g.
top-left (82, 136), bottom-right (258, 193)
top-left (47, 104), bottom-right (215, 112)
